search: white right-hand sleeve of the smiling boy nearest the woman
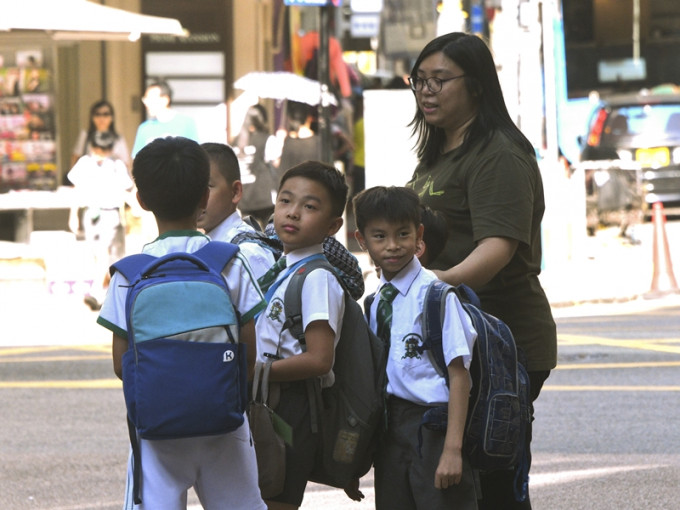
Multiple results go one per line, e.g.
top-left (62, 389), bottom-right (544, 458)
top-left (442, 292), bottom-right (477, 370)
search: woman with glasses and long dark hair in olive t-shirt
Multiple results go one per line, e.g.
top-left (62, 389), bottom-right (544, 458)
top-left (408, 32), bottom-right (557, 509)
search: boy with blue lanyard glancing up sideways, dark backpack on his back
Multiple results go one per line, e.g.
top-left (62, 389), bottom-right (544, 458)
top-left (256, 161), bottom-right (348, 510)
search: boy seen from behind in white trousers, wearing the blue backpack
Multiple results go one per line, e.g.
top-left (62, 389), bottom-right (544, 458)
top-left (97, 137), bottom-right (266, 510)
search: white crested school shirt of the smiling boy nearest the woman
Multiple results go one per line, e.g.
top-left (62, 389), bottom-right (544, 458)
top-left (370, 257), bottom-right (477, 406)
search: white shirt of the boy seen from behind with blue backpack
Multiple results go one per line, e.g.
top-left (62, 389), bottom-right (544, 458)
top-left (97, 230), bottom-right (265, 338)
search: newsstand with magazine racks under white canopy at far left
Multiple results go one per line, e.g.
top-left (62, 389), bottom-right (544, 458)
top-left (0, 0), bottom-right (185, 243)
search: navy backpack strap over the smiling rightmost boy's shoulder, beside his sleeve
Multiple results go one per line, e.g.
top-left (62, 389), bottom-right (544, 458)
top-left (418, 280), bottom-right (456, 386)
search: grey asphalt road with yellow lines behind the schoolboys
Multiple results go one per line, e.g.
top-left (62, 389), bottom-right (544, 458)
top-left (0, 300), bottom-right (680, 510)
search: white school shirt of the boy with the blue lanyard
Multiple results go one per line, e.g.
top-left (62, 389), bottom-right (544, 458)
top-left (255, 244), bottom-right (345, 387)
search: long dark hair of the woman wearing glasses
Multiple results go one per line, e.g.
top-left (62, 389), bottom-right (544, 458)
top-left (409, 32), bottom-right (535, 164)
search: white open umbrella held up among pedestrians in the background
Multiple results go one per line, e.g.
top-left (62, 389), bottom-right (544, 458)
top-left (234, 71), bottom-right (337, 106)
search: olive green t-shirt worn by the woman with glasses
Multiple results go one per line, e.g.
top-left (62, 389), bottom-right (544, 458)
top-left (407, 133), bottom-right (557, 371)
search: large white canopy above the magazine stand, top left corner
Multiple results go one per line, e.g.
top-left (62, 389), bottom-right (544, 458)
top-left (0, 0), bottom-right (187, 40)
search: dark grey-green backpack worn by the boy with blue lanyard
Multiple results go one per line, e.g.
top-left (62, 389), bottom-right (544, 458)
top-left (283, 257), bottom-right (387, 488)
